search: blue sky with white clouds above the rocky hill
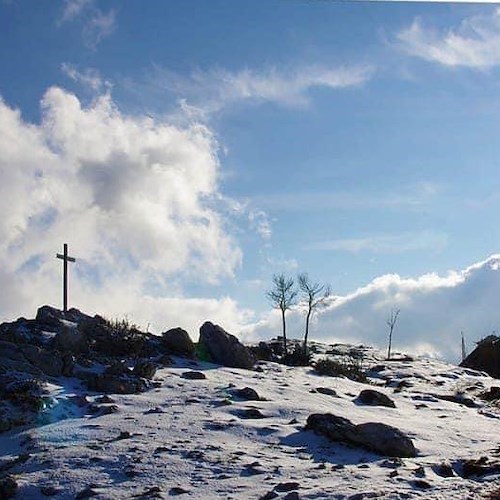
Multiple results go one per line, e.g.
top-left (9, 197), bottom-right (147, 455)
top-left (0, 0), bottom-right (500, 360)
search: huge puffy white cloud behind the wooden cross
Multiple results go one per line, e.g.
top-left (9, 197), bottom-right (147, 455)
top-left (0, 87), bottom-right (246, 334)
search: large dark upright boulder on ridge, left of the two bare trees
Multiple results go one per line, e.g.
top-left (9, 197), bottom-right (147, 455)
top-left (199, 321), bottom-right (256, 370)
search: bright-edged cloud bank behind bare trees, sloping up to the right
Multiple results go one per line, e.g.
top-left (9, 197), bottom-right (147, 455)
top-left (245, 255), bottom-right (500, 362)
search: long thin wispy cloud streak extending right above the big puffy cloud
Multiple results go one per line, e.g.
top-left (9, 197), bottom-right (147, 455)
top-left (148, 66), bottom-right (374, 114)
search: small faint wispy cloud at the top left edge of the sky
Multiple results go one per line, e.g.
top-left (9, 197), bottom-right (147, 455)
top-left (58, 0), bottom-right (116, 50)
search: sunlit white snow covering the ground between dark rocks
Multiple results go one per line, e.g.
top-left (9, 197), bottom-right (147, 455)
top-left (0, 344), bottom-right (500, 499)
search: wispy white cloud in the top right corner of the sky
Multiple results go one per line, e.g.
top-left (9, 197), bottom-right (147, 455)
top-left (397, 8), bottom-right (500, 69)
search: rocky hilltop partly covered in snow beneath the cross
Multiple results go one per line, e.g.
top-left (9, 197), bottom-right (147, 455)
top-left (0, 307), bottom-right (500, 500)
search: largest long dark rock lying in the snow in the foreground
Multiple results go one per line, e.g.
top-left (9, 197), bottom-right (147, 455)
top-left (306, 413), bottom-right (417, 458)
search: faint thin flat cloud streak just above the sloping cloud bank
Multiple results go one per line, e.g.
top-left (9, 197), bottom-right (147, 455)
top-left (306, 231), bottom-right (448, 254)
